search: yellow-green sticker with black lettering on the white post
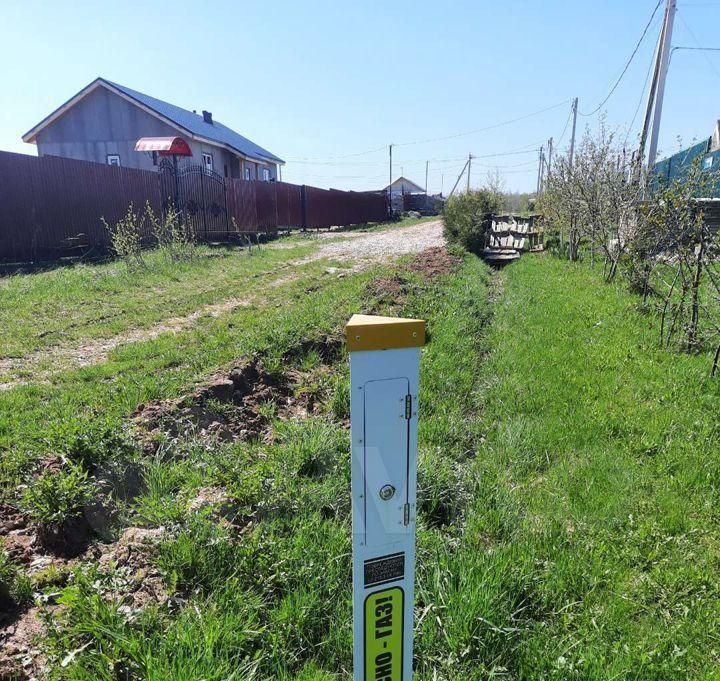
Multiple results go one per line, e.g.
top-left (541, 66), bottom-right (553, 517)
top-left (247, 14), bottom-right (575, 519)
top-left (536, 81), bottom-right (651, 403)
top-left (365, 586), bottom-right (405, 681)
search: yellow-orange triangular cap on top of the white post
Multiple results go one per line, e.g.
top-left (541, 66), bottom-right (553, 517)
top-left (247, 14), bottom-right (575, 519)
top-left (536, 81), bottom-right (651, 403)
top-left (345, 314), bottom-right (425, 352)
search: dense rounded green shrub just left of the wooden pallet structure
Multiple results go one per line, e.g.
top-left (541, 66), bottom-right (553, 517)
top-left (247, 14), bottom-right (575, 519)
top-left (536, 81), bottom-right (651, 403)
top-left (443, 189), bottom-right (502, 253)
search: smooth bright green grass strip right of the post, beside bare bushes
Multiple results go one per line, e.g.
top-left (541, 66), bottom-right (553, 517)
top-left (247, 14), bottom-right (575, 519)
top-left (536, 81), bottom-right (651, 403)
top-left (451, 258), bottom-right (720, 679)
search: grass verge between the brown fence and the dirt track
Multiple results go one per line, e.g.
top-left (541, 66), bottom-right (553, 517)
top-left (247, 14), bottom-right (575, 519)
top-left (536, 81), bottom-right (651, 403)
top-left (0, 240), bottom-right (316, 357)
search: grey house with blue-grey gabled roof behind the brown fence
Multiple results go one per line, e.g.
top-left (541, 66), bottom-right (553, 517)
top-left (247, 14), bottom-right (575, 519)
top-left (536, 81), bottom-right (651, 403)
top-left (23, 78), bottom-right (285, 181)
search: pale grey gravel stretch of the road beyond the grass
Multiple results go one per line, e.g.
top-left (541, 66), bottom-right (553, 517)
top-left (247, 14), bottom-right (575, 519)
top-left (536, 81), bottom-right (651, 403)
top-left (311, 220), bottom-right (445, 267)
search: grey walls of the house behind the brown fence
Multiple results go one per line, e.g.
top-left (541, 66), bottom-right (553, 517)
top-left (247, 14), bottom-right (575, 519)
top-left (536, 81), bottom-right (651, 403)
top-left (36, 87), bottom-right (277, 179)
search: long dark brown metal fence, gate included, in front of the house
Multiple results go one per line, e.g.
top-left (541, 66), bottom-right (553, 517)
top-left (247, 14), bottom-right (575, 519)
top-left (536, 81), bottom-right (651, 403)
top-left (0, 152), bottom-right (389, 262)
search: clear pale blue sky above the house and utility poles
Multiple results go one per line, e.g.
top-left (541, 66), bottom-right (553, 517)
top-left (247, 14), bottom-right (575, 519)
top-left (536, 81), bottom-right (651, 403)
top-left (0, 0), bottom-right (720, 193)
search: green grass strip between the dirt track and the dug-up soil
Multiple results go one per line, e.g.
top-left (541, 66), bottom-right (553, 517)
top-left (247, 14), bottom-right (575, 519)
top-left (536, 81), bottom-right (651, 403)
top-left (0, 261), bottom-right (372, 498)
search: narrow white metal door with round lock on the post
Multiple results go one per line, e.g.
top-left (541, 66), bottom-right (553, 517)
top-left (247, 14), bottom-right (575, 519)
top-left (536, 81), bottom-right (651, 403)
top-left (364, 378), bottom-right (409, 546)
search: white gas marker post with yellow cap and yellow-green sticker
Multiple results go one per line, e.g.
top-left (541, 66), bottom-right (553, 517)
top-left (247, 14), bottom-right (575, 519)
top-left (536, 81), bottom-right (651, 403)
top-left (346, 315), bottom-right (425, 681)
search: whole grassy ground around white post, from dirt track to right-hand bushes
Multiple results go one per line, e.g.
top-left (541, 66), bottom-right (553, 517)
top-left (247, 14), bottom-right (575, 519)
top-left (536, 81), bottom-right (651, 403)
top-left (0, 238), bottom-right (720, 681)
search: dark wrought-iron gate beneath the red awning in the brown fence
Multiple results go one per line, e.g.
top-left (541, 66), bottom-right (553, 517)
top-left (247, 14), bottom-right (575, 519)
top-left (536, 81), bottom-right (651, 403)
top-left (159, 159), bottom-right (230, 241)
